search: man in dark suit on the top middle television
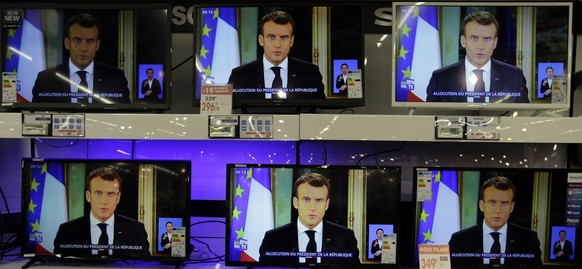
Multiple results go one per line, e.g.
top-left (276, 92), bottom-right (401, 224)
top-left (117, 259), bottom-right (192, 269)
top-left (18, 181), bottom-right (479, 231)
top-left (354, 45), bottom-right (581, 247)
top-left (228, 11), bottom-right (325, 100)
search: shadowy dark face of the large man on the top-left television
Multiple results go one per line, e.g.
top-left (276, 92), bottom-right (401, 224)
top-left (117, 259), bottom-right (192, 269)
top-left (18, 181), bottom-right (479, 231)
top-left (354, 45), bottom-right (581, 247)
top-left (65, 24), bottom-right (100, 69)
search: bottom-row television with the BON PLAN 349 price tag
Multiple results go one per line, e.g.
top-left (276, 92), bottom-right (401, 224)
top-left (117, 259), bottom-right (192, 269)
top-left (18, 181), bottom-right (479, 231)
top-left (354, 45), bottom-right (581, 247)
top-left (414, 167), bottom-right (582, 268)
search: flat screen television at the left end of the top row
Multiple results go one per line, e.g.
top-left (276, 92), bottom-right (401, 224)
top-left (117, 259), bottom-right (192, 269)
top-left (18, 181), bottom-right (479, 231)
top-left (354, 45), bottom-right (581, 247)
top-left (0, 2), bottom-right (172, 111)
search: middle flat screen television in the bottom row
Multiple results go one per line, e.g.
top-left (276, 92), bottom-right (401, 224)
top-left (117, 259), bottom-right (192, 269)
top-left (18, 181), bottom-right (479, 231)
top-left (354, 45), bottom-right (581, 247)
top-left (226, 164), bottom-right (400, 267)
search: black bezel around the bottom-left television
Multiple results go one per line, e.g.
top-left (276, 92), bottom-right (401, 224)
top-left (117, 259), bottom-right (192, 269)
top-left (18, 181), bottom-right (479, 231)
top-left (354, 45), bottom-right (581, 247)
top-left (19, 158), bottom-right (192, 262)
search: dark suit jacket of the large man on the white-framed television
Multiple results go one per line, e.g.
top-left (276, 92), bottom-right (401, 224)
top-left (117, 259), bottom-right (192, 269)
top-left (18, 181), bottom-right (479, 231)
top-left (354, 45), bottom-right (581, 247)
top-left (426, 59), bottom-right (529, 103)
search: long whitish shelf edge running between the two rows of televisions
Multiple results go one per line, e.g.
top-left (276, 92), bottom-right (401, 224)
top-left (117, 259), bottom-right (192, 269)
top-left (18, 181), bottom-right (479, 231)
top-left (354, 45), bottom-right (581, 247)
top-left (0, 113), bottom-right (582, 143)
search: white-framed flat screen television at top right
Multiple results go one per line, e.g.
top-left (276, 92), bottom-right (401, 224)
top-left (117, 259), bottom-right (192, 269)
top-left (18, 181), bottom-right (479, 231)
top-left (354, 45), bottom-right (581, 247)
top-left (391, 1), bottom-right (574, 110)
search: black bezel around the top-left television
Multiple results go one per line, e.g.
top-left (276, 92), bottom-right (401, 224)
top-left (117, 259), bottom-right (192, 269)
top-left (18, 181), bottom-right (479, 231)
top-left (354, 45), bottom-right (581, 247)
top-left (0, 2), bottom-right (172, 113)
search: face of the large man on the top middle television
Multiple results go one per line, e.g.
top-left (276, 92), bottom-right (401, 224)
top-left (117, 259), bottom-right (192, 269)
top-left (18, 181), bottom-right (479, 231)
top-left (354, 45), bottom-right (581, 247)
top-left (259, 21), bottom-right (295, 65)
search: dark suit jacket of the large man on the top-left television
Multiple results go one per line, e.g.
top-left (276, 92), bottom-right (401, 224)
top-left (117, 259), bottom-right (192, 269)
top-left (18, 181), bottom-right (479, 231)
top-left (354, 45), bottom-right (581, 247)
top-left (32, 61), bottom-right (130, 103)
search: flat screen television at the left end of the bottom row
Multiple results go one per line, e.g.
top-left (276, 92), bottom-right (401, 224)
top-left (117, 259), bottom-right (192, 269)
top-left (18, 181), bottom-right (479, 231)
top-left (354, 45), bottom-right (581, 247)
top-left (21, 159), bottom-right (191, 265)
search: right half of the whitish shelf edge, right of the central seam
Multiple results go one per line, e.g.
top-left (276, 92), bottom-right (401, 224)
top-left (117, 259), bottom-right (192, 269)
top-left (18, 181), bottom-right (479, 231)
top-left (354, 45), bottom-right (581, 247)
top-left (299, 114), bottom-right (582, 143)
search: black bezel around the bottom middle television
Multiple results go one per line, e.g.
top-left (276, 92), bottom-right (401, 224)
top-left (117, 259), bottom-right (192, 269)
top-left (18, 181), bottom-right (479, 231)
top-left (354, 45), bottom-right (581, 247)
top-left (225, 163), bottom-right (406, 268)
